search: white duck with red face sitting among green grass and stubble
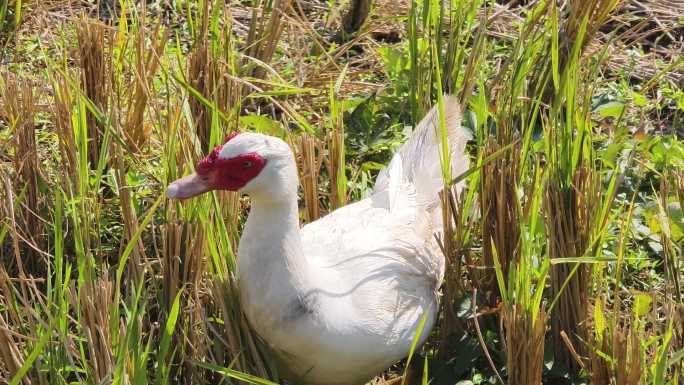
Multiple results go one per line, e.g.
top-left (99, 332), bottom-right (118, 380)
top-left (167, 97), bottom-right (468, 385)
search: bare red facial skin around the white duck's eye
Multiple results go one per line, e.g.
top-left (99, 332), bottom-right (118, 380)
top-left (196, 132), bottom-right (266, 191)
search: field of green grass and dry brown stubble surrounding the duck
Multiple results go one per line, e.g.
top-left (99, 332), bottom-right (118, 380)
top-left (0, 0), bottom-right (684, 385)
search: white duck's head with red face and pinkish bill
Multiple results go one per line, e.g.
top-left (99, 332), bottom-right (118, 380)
top-left (166, 132), bottom-right (297, 199)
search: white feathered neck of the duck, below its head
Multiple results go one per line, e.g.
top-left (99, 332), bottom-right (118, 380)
top-left (238, 171), bottom-right (310, 322)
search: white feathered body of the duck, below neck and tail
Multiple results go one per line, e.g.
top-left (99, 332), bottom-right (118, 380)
top-left (238, 182), bottom-right (442, 384)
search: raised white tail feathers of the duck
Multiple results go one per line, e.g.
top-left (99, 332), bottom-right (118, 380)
top-left (374, 95), bottom-right (471, 205)
